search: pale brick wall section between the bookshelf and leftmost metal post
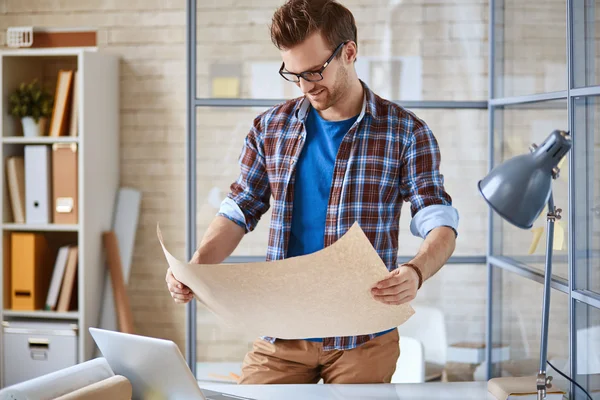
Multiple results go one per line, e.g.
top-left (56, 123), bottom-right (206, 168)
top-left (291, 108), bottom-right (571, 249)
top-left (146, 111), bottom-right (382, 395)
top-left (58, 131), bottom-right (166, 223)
top-left (0, 0), bottom-right (186, 354)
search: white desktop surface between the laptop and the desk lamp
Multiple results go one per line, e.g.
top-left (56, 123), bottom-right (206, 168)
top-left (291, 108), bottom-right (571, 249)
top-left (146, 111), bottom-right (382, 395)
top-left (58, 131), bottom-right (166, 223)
top-left (200, 381), bottom-right (496, 400)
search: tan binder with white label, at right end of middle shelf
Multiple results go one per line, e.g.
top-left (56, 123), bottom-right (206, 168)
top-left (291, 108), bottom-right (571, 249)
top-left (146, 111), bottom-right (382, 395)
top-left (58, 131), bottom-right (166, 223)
top-left (52, 143), bottom-right (78, 224)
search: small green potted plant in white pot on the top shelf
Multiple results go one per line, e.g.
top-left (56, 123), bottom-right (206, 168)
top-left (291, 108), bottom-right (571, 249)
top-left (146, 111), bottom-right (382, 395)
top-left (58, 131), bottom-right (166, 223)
top-left (8, 79), bottom-right (53, 136)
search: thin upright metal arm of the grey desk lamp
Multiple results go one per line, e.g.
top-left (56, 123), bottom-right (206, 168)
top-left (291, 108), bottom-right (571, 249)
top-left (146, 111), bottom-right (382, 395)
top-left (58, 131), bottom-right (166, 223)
top-left (537, 191), bottom-right (562, 400)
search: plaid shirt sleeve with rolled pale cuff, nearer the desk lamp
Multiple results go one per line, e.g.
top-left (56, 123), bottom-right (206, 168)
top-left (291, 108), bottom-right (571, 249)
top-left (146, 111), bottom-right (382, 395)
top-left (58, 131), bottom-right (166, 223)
top-left (400, 121), bottom-right (459, 238)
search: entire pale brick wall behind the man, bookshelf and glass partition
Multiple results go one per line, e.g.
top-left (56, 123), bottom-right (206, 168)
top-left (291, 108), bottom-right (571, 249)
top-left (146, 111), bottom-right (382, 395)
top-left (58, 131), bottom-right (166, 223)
top-left (0, 0), bottom-right (566, 368)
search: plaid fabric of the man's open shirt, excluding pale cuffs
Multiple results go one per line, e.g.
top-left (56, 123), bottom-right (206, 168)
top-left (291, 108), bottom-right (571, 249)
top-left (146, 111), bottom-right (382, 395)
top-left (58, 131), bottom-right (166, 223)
top-left (221, 83), bottom-right (452, 350)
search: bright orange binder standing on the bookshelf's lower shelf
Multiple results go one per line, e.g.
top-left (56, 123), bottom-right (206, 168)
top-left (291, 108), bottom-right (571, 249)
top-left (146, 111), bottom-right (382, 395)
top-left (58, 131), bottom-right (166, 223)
top-left (11, 232), bottom-right (52, 310)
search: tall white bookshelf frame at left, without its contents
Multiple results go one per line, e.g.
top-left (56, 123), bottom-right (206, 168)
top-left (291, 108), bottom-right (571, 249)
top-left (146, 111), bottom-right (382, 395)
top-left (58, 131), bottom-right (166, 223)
top-left (0, 48), bottom-right (119, 388)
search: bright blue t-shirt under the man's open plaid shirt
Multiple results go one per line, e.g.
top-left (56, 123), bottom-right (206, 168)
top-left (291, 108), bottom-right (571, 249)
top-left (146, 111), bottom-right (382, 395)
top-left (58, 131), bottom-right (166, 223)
top-left (287, 108), bottom-right (389, 342)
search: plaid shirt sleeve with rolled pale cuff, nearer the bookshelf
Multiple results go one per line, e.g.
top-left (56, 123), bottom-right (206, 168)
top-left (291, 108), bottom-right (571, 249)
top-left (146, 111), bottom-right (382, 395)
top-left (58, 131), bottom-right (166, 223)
top-left (217, 116), bottom-right (271, 233)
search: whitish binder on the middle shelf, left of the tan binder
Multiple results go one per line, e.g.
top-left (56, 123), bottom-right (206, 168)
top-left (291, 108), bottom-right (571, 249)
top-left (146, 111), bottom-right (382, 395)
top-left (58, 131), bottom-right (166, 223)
top-left (24, 145), bottom-right (52, 224)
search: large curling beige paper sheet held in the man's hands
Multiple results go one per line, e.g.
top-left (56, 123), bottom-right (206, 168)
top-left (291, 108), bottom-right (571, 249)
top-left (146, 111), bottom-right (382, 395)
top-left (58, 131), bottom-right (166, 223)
top-left (157, 223), bottom-right (414, 339)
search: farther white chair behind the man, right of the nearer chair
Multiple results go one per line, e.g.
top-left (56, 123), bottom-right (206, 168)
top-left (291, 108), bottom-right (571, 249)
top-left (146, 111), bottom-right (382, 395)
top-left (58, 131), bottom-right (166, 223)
top-left (398, 305), bottom-right (448, 381)
